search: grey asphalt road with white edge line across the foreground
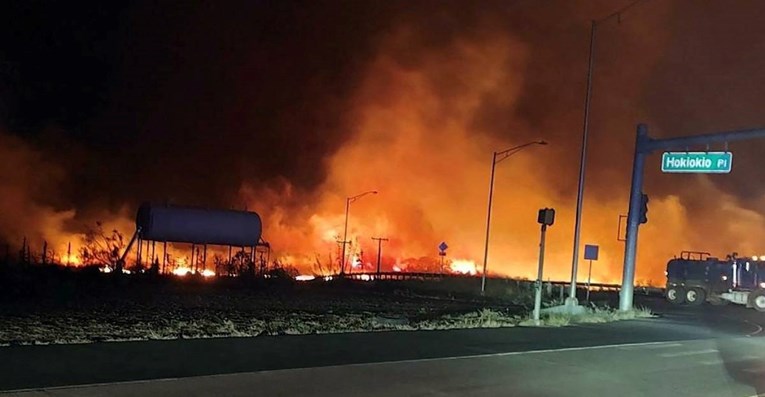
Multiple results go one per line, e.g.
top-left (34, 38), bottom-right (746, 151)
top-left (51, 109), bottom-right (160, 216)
top-left (0, 300), bottom-right (765, 397)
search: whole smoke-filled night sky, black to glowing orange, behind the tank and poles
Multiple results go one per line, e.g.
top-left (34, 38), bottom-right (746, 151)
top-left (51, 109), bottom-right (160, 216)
top-left (0, 1), bottom-right (765, 282)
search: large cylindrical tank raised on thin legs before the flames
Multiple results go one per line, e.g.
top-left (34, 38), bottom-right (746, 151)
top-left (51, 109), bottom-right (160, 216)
top-left (118, 203), bottom-right (270, 271)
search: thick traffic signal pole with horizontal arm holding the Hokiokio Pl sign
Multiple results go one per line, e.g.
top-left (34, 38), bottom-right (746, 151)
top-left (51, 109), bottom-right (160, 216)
top-left (619, 124), bottom-right (765, 311)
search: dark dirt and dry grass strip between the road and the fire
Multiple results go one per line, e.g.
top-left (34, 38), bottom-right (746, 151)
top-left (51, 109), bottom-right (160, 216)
top-left (0, 269), bottom-right (528, 345)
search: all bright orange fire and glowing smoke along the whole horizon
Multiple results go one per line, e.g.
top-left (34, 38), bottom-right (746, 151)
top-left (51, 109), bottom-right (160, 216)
top-left (0, 0), bottom-right (765, 284)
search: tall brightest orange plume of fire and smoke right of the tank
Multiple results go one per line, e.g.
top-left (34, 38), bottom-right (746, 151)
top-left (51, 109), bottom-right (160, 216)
top-left (233, 23), bottom-right (692, 282)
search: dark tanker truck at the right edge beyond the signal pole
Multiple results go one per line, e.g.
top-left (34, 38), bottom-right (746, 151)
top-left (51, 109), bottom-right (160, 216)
top-left (665, 251), bottom-right (765, 312)
